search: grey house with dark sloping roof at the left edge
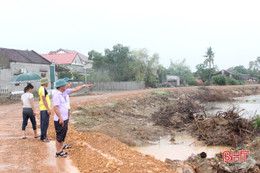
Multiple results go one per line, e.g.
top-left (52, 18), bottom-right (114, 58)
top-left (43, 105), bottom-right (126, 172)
top-left (0, 48), bottom-right (51, 93)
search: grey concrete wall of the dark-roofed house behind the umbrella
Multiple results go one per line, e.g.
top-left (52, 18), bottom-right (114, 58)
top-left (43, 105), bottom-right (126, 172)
top-left (0, 62), bottom-right (50, 93)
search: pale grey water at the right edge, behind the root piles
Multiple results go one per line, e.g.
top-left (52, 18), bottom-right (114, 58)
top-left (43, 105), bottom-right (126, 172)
top-left (206, 95), bottom-right (260, 118)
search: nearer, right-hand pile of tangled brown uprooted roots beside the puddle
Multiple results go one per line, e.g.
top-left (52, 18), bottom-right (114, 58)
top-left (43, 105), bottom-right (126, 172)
top-left (194, 107), bottom-right (260, 147)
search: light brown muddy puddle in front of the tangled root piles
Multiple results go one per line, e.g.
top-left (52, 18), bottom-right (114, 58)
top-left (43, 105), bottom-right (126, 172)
top-left (134, 133), bottom-right (230, 161)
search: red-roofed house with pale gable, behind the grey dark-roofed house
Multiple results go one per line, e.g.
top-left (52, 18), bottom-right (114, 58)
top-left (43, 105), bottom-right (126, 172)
top-left (42, 49), bottom-right (93, 75)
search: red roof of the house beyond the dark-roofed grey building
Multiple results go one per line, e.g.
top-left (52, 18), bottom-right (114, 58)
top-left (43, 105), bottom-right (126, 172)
top-left (42, 53), bottom-right (77, 64)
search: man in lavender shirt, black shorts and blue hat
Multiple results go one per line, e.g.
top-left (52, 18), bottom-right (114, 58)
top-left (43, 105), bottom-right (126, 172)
top-left (52, 79), bottom-right (69, 157)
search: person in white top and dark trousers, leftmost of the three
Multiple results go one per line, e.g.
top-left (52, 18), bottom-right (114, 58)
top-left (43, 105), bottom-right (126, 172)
top-left (21, 84), bottom-right (38, 139)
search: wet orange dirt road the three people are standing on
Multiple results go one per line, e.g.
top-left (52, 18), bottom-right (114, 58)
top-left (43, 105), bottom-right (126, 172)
top-left (0, 85), bottom-right (260, 172)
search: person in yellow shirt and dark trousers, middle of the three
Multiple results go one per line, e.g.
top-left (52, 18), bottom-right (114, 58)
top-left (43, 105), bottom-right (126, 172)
top-left (38, 78), bottom-right (51, 142)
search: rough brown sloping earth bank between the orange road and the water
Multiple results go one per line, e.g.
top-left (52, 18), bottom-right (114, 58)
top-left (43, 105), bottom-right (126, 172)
top-left (72, 86), bottom-right (260, 146)
